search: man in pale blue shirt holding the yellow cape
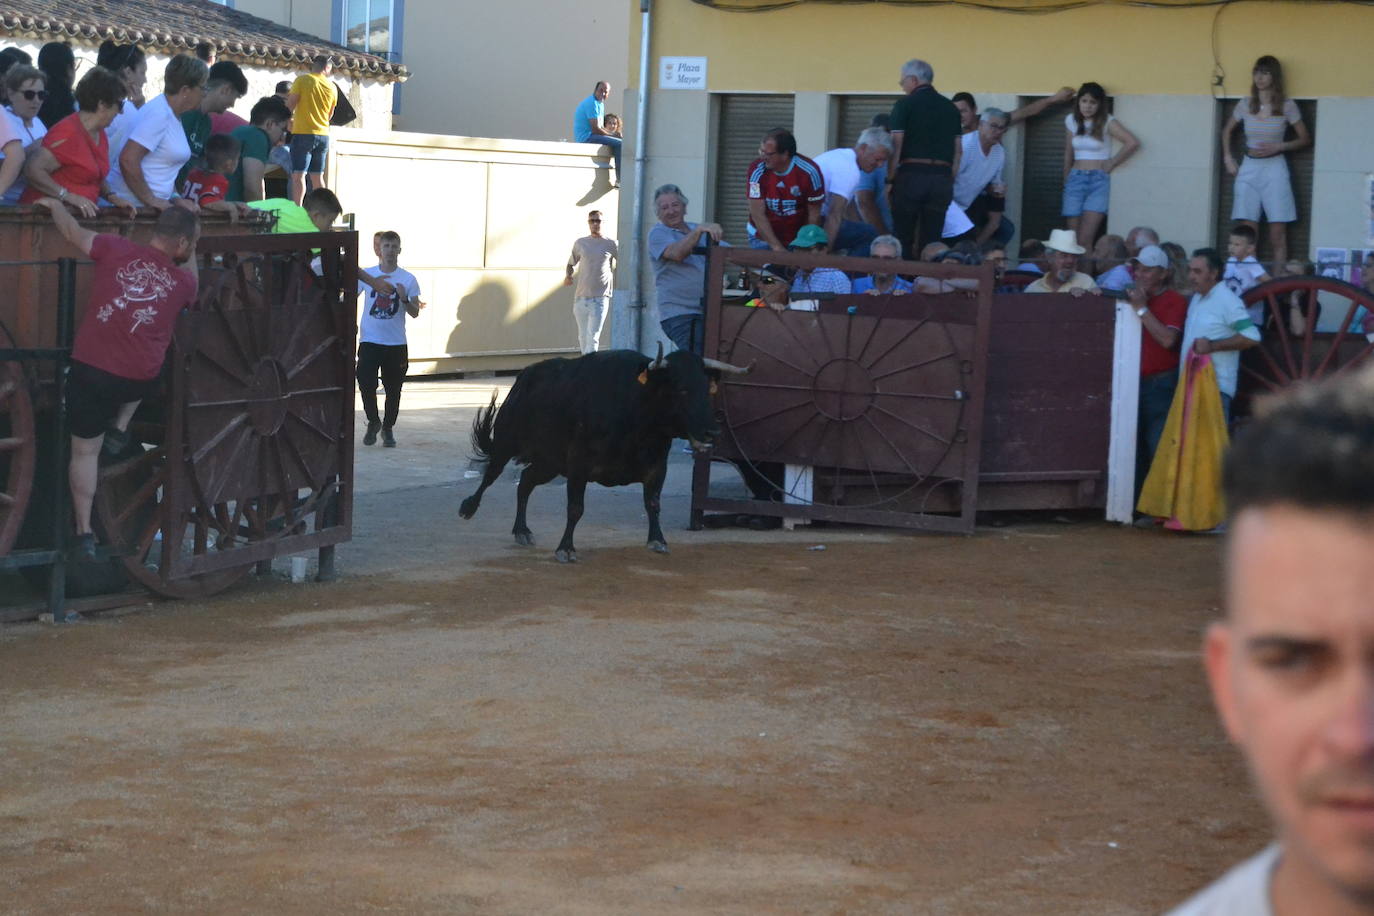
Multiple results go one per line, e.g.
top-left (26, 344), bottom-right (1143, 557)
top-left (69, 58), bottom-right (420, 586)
top-left (1179, 249), bottom-right (1260, 419)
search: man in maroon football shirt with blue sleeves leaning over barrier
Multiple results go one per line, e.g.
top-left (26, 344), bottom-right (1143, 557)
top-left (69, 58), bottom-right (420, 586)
top-left (745, 128), bottom-right (826, 251)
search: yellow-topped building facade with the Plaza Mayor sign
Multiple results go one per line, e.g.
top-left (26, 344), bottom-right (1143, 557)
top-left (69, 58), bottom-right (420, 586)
top-left (617, 0), bottom-right (1374, 345)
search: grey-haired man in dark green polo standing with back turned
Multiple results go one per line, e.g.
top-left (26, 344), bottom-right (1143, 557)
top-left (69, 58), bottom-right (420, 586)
top-left (888, 59), bottom-right (962, 257)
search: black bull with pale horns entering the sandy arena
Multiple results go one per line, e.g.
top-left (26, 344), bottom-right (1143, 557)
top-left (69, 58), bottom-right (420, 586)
top-left (458, 345), bottom-right (749, 563)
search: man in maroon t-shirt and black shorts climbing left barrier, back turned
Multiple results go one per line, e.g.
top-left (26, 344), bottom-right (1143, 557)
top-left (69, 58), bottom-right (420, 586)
top-left (33, 198), bottom-right (201, 559)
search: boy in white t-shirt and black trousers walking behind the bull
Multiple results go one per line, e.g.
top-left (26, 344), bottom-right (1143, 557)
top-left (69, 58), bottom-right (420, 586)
top-left (357, 231), bottom-right (425, 449)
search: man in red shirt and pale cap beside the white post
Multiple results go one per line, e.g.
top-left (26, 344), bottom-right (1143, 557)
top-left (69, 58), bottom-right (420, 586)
top-left (1131, 244), bottom-right (1189, 499)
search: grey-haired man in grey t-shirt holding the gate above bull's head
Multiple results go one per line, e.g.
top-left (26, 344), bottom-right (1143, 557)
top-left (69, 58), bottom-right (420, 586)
top-left (649, 184), bottom-right (724, 356)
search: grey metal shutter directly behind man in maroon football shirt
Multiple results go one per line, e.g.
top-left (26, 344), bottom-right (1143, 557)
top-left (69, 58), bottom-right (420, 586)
top-left (712, 95), bottom-right (796, 244)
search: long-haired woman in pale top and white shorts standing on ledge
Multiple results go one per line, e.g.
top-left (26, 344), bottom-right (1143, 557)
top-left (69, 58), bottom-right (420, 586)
top-left (1221, 55), bottom-right (1312, 264)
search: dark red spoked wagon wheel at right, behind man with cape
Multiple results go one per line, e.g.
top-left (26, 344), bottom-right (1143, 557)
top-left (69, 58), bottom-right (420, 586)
top-left (1237, 276), bottom-right (1374, 413)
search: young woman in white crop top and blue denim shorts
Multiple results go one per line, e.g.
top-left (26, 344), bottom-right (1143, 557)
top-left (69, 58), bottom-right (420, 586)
top-left (1063, 82), bottom-right (1140, 250)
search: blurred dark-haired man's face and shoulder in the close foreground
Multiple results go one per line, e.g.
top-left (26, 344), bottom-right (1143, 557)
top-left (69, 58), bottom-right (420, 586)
top-left (1173, 368), bottom-right (1374, 916)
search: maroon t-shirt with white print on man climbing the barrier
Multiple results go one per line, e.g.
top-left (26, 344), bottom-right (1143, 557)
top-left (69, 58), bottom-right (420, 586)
top-left (71, 235), bottom-right (195, 382)
